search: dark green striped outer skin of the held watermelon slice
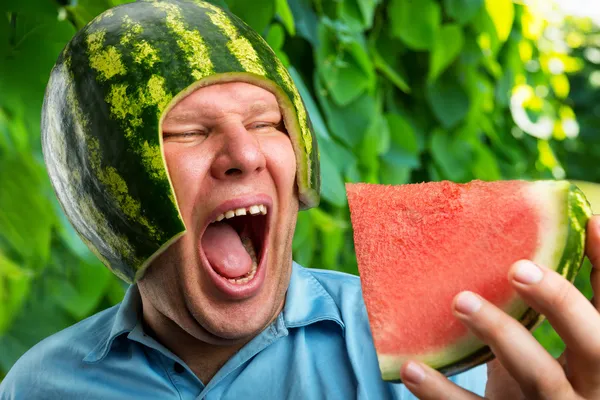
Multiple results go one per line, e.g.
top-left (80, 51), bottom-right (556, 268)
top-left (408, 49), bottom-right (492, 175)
top-left (381, 184), bottom-right (592, 383)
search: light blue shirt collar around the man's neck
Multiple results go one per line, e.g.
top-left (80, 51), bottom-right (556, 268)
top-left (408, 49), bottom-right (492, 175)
top-left (83, 262), bottom-right (345, 363)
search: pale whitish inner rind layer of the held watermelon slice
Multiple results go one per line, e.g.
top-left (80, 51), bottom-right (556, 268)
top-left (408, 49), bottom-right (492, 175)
top-left (377, 181), bottom-right (571, 380)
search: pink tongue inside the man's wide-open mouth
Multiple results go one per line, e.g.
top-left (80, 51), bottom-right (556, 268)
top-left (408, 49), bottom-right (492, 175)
top-left (202, 222), bottom-right (252, 279)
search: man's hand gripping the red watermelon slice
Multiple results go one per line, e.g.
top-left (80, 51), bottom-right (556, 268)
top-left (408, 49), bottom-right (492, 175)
top-left (400, 216), bottom-right (600, 400)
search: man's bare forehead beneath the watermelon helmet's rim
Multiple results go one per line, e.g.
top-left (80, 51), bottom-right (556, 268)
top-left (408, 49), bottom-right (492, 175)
top-left (166, 82), bottom-right (279, 120)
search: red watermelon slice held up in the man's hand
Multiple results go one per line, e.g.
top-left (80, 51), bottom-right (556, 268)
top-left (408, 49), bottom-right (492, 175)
top-left (346, 181), bottom-right (591, 381)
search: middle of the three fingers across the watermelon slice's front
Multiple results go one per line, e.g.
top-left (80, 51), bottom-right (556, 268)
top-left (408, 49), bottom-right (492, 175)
top-left (454, 292), bottom-right (572, 400)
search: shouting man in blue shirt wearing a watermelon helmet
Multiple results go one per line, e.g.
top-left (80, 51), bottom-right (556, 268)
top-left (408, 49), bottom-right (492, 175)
top-left (0, 1), bottom-right (600, 399)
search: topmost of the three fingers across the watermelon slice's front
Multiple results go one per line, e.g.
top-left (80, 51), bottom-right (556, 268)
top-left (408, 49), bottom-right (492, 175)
top-left (509, 261), bottom-right (600, 368)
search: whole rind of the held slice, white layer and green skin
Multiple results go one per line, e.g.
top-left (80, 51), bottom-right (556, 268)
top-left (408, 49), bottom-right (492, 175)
top-left (377, 181), bottom-right (592, 382)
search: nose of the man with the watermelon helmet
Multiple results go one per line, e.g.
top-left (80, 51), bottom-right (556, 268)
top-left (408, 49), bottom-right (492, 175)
top-left (211, 123), bottom-right (266, 179)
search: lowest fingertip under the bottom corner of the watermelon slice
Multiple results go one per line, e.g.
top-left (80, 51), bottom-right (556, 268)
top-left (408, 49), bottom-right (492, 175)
top-left (400, 361), bottom-right (483, 400)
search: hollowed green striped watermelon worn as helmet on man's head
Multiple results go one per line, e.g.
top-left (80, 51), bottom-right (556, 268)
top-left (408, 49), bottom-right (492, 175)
top-left (42, 0), bottom-right (320, 282)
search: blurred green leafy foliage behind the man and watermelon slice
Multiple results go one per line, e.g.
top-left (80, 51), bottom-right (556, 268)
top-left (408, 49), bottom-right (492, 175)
top-left (0, 0), bottom-right (600, 379)
